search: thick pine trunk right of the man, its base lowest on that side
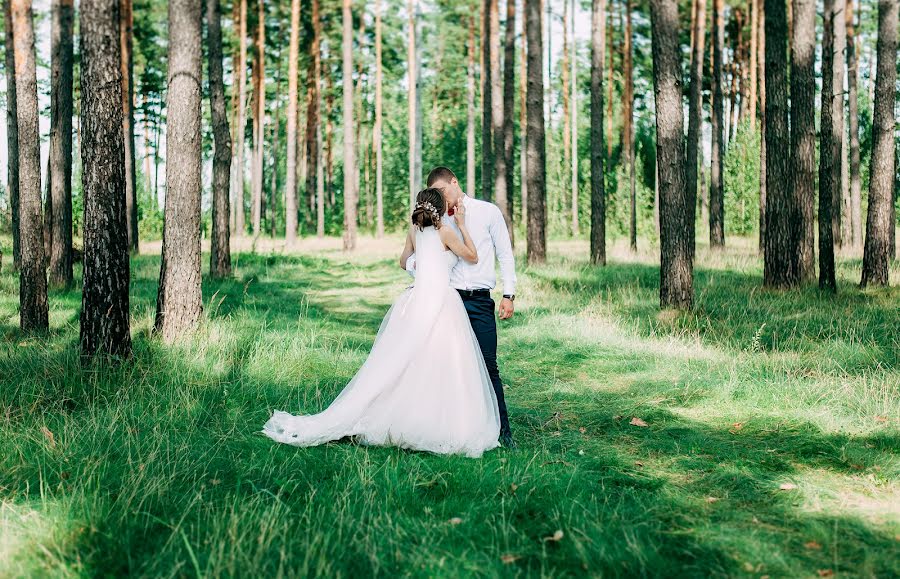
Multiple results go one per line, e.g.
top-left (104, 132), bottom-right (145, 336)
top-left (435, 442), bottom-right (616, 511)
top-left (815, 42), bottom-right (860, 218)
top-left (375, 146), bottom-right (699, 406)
top-left (650, 0), bottom-right (694, 309)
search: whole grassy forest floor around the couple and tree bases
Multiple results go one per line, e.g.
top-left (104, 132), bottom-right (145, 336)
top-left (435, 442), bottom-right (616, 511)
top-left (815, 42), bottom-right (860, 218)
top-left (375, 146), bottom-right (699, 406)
top-left (0, 237), bottom-right (900, 577)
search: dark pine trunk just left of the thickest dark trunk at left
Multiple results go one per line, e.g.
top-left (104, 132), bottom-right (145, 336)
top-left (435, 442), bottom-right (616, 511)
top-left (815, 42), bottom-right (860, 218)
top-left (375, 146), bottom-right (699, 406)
top-left (47, 0), bottom-right (75, 287)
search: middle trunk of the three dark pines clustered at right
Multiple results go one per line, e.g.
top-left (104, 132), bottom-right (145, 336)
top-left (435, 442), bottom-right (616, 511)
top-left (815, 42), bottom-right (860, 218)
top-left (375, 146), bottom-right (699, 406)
top-left (790, 0), bottom-right (816, 281)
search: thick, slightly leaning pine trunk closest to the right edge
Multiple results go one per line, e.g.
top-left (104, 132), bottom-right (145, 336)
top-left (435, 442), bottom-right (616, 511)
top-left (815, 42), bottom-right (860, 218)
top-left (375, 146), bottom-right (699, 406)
top-left (860, 0), bottom-right (898, 287)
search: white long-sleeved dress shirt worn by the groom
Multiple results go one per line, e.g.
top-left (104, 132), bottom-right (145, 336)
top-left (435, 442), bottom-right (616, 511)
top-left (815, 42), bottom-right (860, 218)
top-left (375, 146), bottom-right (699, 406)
top-left (406, 195), bottom-right (516, 295)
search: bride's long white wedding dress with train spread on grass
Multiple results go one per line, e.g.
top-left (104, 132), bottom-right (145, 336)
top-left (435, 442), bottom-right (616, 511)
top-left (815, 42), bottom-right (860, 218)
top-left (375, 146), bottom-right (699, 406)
top-left (263, 227), bottom-right (500, 457)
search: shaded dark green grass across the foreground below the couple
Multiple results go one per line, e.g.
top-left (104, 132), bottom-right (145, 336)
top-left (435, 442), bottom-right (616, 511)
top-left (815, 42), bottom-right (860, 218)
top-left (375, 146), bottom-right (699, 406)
top-left (0, 340), bottom-right (900, 576)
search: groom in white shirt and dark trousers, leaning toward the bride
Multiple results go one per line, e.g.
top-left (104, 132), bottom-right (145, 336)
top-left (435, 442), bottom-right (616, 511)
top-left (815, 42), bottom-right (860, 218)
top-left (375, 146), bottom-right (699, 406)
top-left (401, 167), bottom-right (516, 448)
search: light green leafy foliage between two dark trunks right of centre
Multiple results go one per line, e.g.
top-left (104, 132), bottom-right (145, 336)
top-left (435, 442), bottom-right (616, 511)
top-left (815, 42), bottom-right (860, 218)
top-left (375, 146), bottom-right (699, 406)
top-left (725, 121), bottom-right (760, 235)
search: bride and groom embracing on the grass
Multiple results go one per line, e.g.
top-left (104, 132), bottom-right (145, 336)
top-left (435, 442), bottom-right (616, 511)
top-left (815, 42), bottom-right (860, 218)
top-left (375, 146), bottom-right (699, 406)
top-left (263, 167), bottom-right (516, 457)
